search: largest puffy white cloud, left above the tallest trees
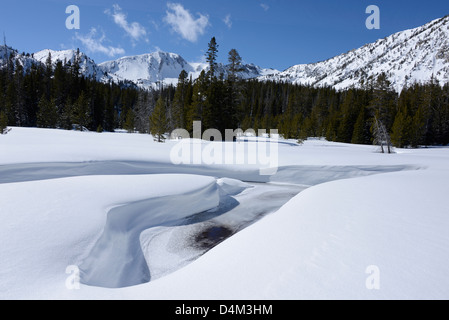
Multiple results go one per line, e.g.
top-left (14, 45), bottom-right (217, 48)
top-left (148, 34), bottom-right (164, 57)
top-left (164, 2), bottom-right (209, 42)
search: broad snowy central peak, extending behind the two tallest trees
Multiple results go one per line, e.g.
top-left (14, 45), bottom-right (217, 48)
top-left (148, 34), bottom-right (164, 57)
top-left (99, 51), bottom-right (279, 88)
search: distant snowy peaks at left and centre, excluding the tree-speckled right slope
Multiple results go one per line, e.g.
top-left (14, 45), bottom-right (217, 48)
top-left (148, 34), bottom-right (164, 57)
top-left (0, 46), bottom-right (279, 89)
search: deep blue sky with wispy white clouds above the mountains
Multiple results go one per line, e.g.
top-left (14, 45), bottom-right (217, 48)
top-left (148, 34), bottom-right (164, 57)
top-left (0, 0), bottom-right (449, 70)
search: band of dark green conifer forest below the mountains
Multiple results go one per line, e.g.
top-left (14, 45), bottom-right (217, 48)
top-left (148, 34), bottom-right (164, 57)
top-left (0, 38), bottom-right (449, 147)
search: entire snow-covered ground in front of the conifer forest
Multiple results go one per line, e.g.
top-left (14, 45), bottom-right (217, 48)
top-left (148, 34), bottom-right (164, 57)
top-left (0, 128), bottom-right (449, 299)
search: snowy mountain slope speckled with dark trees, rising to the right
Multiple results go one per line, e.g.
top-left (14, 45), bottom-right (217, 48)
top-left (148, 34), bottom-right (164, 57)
top-left (259, 16), bottom-right (449, 92)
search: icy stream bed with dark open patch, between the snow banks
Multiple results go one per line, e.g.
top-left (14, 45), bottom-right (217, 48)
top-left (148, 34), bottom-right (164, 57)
top-left (140, 183), bottom-right (306, 280)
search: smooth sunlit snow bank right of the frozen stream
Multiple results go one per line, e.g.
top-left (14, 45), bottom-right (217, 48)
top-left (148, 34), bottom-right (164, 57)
top-left (158, 171), bottom-right (449, 299)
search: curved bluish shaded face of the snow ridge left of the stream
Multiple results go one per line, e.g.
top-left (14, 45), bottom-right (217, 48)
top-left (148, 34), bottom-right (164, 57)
top-left (80, 178), bottom-right (219, 288)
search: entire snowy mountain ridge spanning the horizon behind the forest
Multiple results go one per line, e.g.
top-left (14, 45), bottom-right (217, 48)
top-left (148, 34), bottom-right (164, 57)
top-left (0, 15), bottom-right (449, 92)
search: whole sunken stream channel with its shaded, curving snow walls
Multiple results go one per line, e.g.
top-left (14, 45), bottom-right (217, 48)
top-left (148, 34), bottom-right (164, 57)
top-left (0, 161), bottom-right (416, 288)
